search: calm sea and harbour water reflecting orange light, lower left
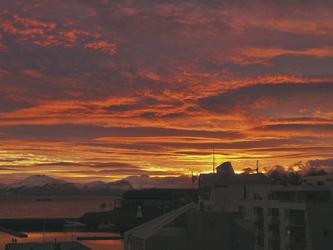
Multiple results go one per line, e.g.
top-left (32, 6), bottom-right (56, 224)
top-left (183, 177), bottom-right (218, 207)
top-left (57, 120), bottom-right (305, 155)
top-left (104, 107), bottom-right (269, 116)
top-left (0, 197), bottom-right (124, 250)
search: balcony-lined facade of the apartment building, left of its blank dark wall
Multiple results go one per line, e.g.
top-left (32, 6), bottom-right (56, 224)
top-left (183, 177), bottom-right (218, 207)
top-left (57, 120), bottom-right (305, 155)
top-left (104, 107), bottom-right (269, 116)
top-left (239, 188), bottom-right (312, 250)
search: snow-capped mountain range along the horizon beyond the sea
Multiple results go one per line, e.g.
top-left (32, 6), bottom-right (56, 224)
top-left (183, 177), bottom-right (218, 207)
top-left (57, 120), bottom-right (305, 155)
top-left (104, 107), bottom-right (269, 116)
top-left (0, 175), bottom-right (134, 196)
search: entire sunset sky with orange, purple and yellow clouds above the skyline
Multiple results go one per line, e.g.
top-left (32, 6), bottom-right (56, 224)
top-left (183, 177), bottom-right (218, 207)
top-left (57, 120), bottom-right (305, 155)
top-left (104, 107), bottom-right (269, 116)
top-left (0, 0), bottom-right (333, 186)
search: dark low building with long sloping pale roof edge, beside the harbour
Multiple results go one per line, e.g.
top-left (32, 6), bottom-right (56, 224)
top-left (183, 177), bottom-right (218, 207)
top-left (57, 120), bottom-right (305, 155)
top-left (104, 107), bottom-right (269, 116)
top-left (124, 203), bottom-right (237, 250)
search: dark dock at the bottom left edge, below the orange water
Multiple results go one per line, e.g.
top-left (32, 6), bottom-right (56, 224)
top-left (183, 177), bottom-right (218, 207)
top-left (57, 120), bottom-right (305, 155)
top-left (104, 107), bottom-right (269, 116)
top-left (5, 241), bottom-right (91, 250)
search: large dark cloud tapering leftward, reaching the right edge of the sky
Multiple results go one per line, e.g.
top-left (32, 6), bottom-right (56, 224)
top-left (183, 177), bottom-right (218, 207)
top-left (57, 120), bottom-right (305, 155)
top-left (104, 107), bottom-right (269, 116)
top-left (198, 82), bottom-right (333, 114)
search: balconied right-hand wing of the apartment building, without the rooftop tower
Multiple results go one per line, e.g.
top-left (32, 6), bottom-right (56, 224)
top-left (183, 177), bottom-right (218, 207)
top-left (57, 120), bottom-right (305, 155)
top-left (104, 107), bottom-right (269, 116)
top-left (239, 175), bottom-right (333, 250)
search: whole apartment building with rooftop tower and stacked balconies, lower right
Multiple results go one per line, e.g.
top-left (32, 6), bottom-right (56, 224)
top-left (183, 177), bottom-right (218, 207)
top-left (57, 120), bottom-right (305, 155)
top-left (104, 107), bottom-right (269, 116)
top-left (199, 162), bottom-right (333, 250)
